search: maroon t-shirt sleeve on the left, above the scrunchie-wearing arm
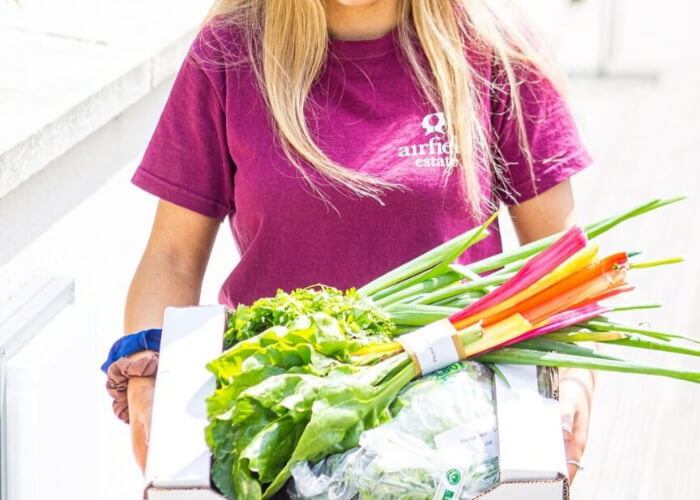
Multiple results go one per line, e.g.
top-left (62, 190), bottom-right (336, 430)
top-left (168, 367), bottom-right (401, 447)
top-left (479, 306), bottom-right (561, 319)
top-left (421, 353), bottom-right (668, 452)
top-left (132, 32), bottom-right (235, 220)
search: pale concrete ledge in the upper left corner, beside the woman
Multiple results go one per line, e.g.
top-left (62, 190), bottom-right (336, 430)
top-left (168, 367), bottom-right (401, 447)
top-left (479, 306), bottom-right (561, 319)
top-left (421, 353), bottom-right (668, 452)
top-left (0, 0), bottom-right (211, 198)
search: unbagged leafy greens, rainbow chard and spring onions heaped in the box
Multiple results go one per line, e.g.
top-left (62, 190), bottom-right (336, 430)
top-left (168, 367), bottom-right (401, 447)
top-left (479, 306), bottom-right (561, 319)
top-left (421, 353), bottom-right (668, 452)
top-left (206, 199), bottom-right (700, 499)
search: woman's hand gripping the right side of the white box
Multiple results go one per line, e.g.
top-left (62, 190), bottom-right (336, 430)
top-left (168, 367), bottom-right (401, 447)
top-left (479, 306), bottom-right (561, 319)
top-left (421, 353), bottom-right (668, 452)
top-left (559, 368), bottom-right (595, 483)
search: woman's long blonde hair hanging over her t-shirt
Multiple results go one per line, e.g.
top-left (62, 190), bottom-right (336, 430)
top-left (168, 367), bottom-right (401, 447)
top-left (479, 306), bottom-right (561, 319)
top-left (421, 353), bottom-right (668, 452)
top-left (203, 0), bottom-right (560, 216)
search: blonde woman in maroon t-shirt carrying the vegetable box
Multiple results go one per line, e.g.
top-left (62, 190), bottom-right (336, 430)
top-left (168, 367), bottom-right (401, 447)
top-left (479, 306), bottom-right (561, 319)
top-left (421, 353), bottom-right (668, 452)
top-left (115, 0), bottom-right (593, 488)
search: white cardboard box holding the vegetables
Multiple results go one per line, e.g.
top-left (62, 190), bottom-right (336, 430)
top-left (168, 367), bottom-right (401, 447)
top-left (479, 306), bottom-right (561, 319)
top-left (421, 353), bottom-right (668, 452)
top-left (144, 306), bottom-right (568, 500)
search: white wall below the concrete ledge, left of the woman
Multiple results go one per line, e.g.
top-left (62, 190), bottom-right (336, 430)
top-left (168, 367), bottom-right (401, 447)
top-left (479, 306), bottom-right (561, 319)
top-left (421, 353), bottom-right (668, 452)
top-left (0, 76), bottom-right (237, 500)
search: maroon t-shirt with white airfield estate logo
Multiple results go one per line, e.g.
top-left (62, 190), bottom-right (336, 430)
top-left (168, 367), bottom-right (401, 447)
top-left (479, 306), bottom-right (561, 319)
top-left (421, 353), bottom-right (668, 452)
top-left (133, 28), bottom-right (590, 306)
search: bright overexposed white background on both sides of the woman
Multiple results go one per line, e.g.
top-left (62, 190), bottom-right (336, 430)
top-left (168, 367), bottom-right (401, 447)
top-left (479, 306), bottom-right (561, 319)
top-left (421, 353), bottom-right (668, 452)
top-left (0, 0), bottom-right (700, 500)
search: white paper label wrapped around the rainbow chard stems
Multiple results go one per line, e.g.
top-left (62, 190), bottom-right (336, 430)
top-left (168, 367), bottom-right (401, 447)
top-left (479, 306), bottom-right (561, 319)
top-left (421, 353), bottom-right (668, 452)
top-left (398, 319), bottom-right (459, 375)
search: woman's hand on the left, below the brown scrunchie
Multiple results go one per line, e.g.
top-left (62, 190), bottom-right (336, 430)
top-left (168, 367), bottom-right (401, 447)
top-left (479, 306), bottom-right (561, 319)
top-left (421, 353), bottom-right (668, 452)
top-left (126, 377), bottom-right (156, 473)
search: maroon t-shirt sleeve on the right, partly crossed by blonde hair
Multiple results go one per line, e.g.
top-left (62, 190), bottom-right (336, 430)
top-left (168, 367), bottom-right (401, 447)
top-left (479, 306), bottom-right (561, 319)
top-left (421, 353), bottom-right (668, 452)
top-left (491, 63), bottom-right (592, 205)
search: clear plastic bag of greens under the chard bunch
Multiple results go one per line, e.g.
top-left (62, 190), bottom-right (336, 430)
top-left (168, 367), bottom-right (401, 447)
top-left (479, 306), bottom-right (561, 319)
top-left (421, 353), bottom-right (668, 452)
top-left (288, 362), bottom-right (498, 500)
